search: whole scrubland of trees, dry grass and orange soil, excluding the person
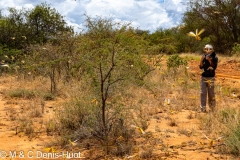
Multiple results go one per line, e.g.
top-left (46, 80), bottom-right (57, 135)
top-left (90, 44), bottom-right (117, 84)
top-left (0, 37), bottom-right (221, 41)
top-left (0, 0), bottom-right (240, 160)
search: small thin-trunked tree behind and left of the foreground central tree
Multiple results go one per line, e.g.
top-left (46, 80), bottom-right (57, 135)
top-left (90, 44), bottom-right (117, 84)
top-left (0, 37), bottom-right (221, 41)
top-left (24, 32), bottom-right (76, 93)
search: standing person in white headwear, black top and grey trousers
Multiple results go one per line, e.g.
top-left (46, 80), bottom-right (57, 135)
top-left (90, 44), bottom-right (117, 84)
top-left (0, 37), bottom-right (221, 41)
top-left (199, 44), bottom-right (218, 112)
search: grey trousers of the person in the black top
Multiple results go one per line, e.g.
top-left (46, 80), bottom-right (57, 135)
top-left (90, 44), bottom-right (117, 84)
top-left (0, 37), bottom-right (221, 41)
top-left (200, 77), bottom-right (216, 111)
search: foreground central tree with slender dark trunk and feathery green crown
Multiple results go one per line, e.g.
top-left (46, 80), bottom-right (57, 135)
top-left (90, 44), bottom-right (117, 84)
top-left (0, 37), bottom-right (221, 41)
top-left (74, 16), bottom-right (150, 152)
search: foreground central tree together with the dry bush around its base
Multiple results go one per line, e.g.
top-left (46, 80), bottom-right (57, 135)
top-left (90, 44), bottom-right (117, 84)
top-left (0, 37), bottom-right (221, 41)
top-left (52, 16), bottom-right (151, 154)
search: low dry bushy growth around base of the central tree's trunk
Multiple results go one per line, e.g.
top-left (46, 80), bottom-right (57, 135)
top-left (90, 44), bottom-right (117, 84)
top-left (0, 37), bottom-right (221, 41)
top-left (56, 94), bottom-right (133, 155)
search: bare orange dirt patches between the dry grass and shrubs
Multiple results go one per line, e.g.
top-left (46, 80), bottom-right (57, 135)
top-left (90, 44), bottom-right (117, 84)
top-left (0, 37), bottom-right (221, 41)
top-left (0, 54), bottom-right (240, 160)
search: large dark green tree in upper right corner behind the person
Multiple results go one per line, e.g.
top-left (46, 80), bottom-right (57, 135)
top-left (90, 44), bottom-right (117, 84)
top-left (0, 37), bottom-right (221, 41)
top-left (183, 0), bottom-right (240, 53)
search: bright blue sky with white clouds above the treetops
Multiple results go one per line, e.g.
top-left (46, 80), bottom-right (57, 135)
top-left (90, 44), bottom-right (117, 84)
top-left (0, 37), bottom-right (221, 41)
top-left (0, 0), bottom-right (186, 32)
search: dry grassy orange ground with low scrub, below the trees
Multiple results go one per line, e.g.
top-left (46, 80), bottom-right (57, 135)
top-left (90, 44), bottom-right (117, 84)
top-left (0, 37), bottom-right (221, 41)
top-left (1, 54), bottom-right (240, 159)
